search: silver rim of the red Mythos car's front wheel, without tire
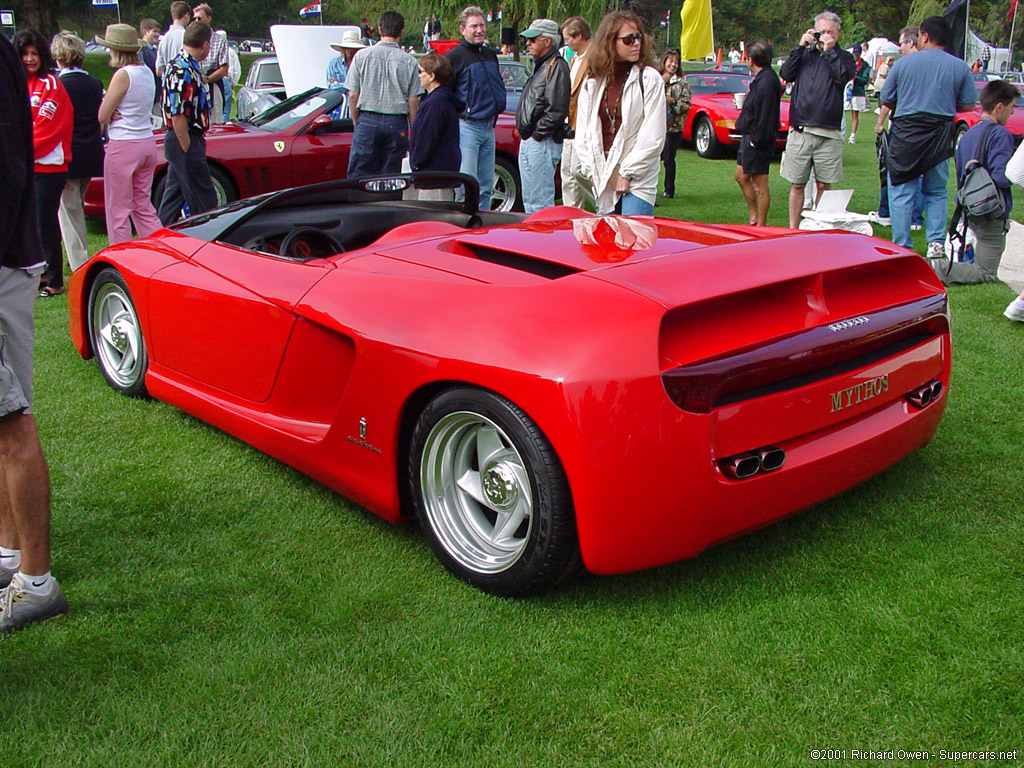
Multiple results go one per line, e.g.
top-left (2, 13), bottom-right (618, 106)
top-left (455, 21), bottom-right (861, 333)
top-left (92, 283), bottom-right (145, 389)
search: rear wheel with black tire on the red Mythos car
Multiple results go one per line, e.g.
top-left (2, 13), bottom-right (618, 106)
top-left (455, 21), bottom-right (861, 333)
top-left (409, 389), bottom-right (581, 597)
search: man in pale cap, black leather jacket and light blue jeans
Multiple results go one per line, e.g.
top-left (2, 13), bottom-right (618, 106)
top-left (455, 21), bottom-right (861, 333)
top-left (515, 18), bottom-right (571, 213)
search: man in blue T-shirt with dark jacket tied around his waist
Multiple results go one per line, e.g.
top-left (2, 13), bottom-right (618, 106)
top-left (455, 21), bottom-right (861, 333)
top-left (882, 16), bottom-right (977, 257)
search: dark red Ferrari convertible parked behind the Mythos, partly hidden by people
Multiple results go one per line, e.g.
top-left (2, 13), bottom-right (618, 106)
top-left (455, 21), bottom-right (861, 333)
top-left (85, 88), bottom-right (522, 216)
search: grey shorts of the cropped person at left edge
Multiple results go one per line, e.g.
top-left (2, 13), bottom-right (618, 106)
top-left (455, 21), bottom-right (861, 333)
top-left (0, 266), bottom-right (43, 416)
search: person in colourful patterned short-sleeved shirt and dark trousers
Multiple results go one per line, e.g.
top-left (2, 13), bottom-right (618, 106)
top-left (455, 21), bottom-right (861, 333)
top-left (158, 22), bottom-right (217, 225)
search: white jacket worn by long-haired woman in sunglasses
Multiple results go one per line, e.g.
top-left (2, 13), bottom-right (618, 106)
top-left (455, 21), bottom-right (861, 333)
top-left (574, 67), bottom-right (666, 214)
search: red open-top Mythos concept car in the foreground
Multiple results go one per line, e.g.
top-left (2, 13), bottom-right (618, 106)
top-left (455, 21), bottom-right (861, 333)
top-left (69, 174), bottom-right (950, 596)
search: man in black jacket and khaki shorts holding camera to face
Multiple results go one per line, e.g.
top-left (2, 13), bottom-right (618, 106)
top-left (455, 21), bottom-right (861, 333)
top-left (779, 10), bottom-right (856, 229)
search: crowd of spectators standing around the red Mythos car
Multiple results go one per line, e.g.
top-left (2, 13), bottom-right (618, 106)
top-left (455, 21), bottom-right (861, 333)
top-left (0, 7), bottom-right (1024, 631)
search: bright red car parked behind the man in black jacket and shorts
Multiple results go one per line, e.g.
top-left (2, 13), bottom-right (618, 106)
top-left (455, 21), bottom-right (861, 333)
top-left (683, 71), bottom-right (790, 158)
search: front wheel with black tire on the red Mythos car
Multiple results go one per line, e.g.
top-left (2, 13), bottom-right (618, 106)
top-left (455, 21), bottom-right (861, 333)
top-left (89, 267), bottom-right (150, 397)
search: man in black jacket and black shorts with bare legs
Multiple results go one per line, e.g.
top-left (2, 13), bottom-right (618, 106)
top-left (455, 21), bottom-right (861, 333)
top-left (736, 40), bottom-right (782, 226)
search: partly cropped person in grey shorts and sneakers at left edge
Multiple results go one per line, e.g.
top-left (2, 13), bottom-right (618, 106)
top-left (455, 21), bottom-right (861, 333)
top-left (0, 35), bottom-right (68, 632)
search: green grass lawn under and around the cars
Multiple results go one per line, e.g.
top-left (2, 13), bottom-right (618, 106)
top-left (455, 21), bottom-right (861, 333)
top-left (8, 121), bottom-right (1024, 768)
